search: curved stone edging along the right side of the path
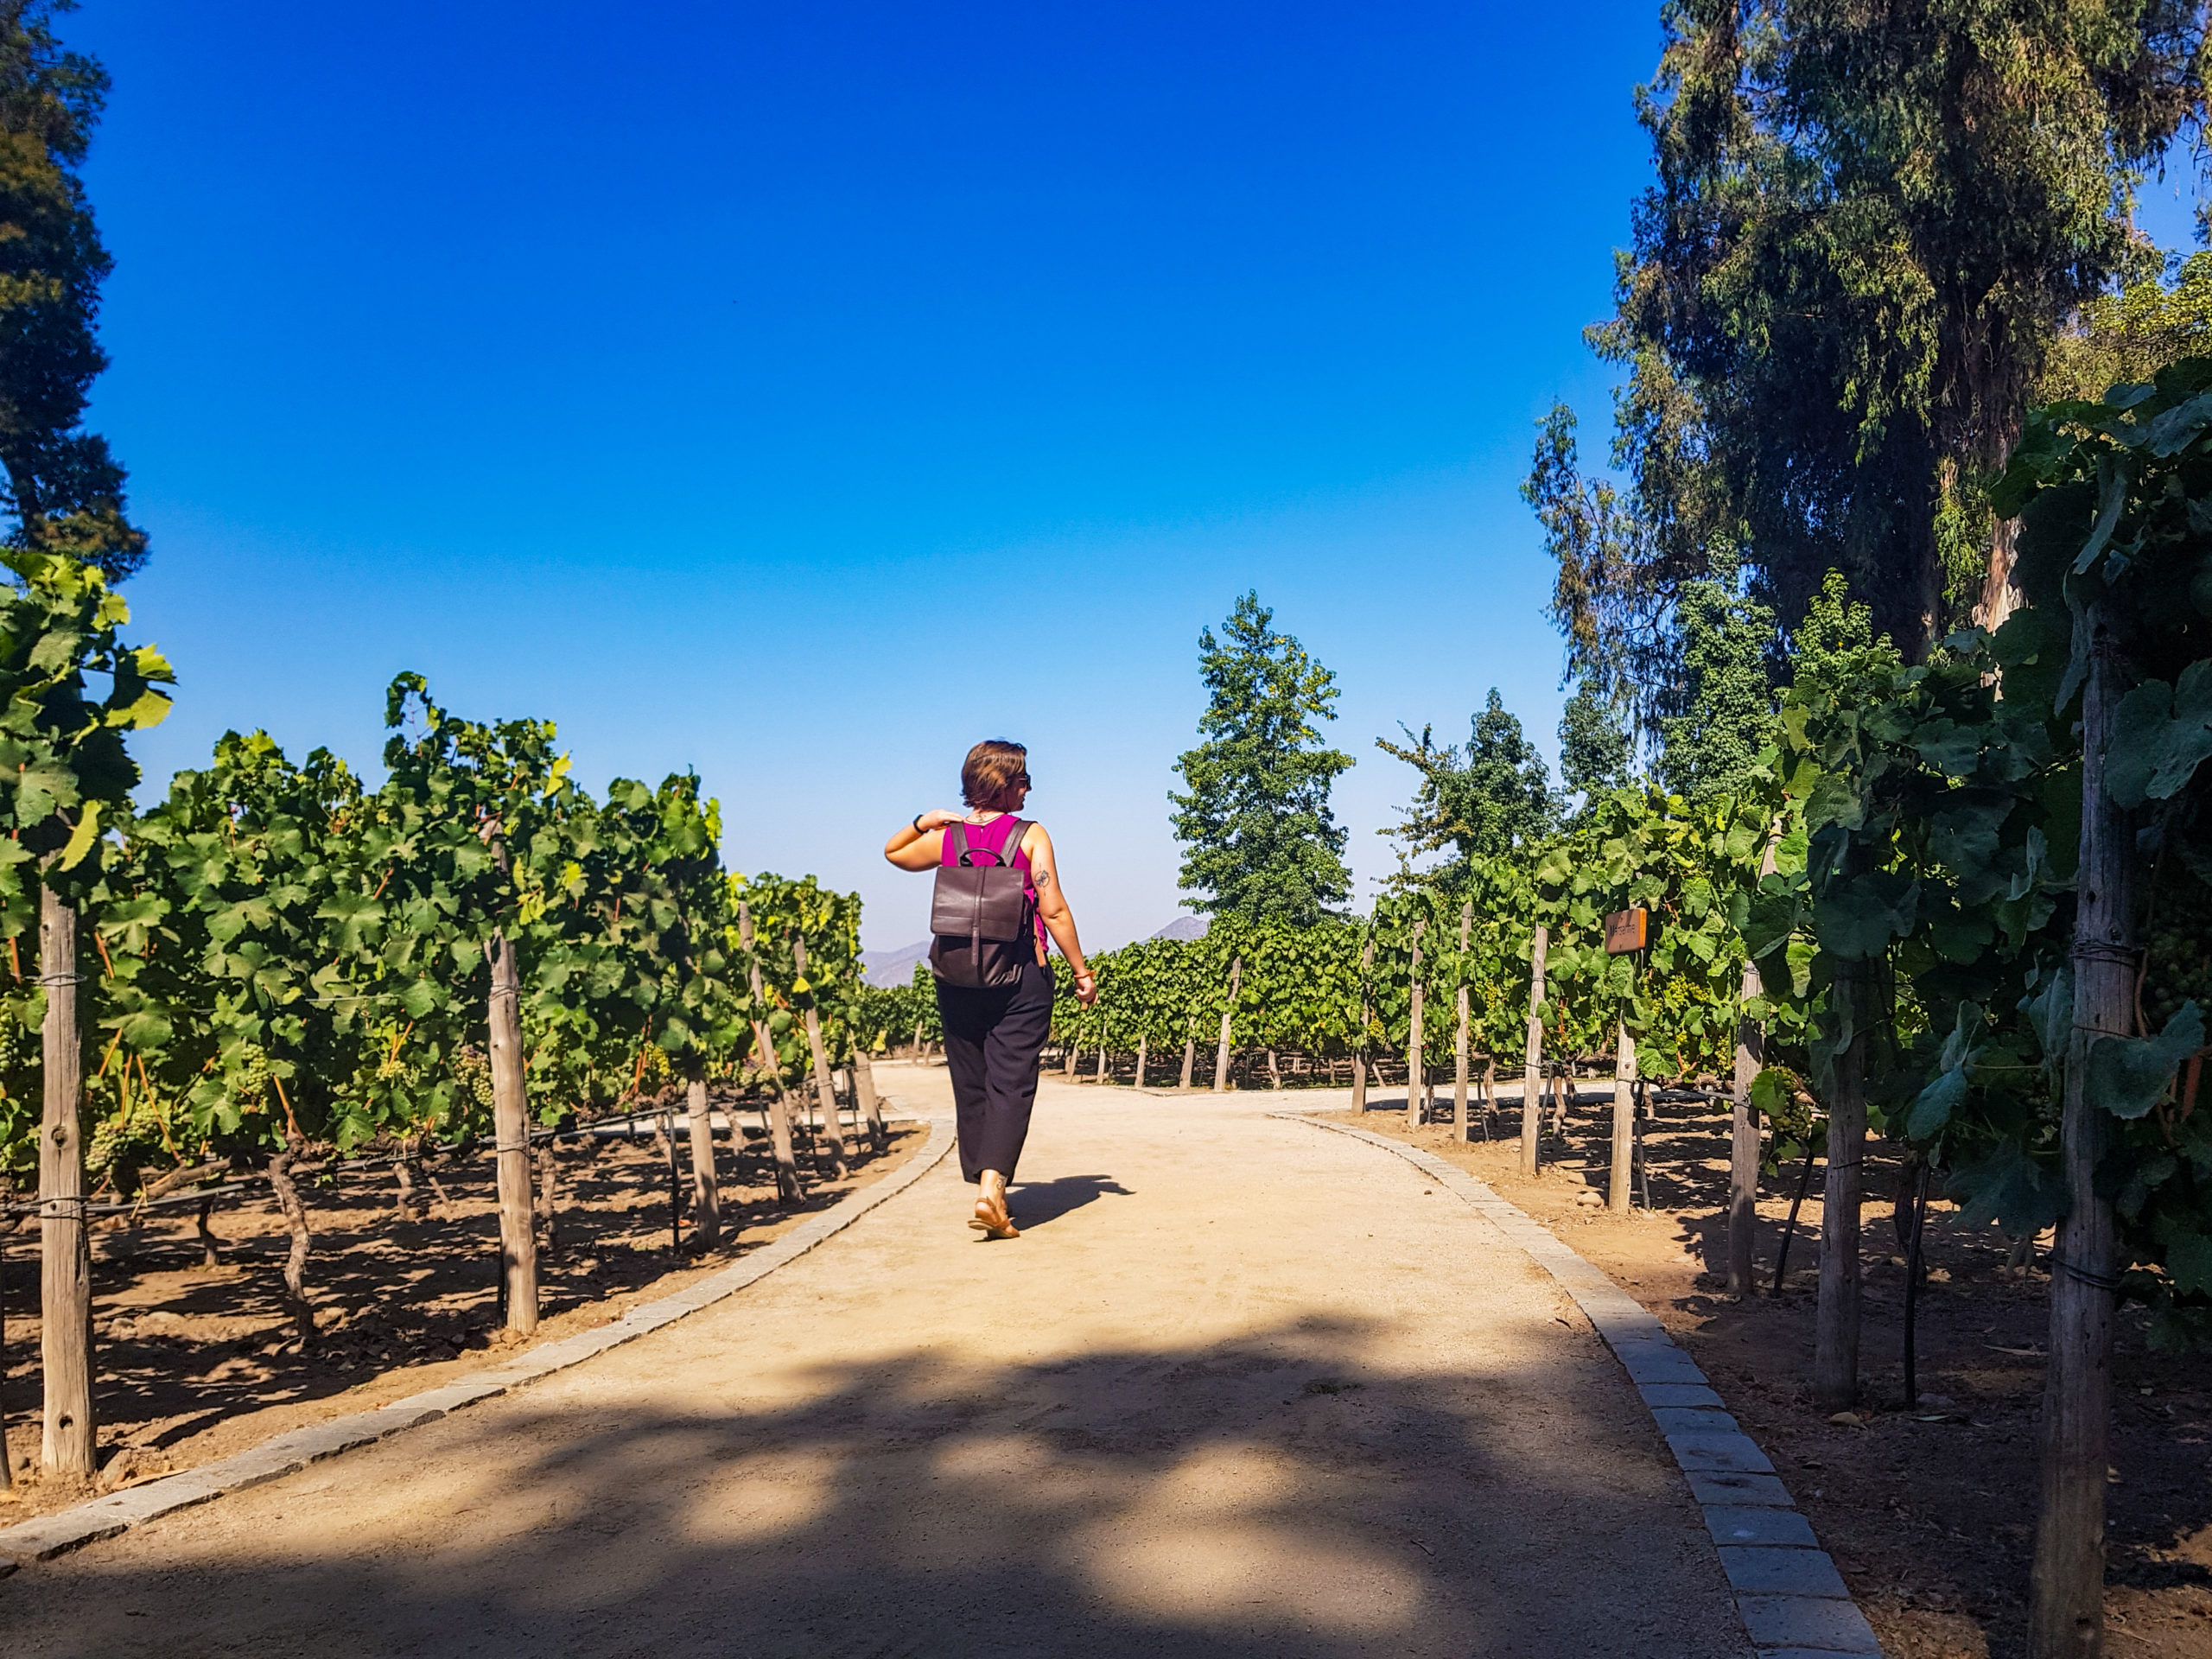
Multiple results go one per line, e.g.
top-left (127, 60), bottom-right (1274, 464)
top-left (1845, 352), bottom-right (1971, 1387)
top-left (1282, 1113), bottom-right (1883, 1659)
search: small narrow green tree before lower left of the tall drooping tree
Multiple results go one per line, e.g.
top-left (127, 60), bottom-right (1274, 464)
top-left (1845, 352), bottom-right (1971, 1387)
top-left (1659, 569), bottom-right (1774, 803)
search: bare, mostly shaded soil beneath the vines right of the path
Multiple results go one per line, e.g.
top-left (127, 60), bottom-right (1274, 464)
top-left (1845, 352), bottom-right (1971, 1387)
top-left (1363, 1084), bottom-right (2212, 1659)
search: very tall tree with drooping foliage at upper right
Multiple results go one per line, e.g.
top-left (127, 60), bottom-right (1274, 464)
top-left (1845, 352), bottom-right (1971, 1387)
top-left (1553, 0), bottom-right (2201, 664)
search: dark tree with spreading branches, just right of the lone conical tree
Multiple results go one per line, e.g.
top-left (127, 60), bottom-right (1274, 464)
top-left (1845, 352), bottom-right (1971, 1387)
top-left (1376, 686), bottom-right (1560, 885)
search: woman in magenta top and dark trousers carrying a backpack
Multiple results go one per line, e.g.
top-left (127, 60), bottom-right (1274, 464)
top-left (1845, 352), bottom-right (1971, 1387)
top-left (882, 741), bottom-right (1097, 1239)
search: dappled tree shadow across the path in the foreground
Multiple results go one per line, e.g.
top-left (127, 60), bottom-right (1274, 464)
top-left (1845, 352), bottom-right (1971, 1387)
top-left (0, 1314), bottom-right (1750, 1659)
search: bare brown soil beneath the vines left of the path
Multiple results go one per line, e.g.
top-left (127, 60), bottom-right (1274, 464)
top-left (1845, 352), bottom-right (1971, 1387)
top-left (0, 1110), bottom-right (927, 1524)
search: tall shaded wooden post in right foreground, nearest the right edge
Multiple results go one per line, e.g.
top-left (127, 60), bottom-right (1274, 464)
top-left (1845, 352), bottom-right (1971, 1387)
top-left (2029, 600), bottom-right (2134, 1659)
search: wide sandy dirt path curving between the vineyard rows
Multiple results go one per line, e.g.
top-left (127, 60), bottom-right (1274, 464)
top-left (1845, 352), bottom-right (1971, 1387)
top-left (0, 1068), bottom-right (1750, 1659)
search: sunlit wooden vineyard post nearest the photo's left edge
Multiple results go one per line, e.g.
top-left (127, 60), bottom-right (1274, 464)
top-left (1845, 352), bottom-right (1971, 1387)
top-left (37, 885), bottom-right (98, 1480)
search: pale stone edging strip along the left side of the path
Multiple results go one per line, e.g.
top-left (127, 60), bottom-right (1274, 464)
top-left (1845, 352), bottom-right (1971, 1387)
top-left (0, 1117), bottom-right (953, 1577)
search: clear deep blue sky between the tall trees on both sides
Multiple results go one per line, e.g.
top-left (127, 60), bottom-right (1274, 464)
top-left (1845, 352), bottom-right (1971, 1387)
top-left (78, 0), bottom-right (1659, 949)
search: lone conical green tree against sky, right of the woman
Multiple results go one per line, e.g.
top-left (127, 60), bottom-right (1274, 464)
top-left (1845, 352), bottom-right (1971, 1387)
top-left (1168, 593), bottom-right (1351, 925)
